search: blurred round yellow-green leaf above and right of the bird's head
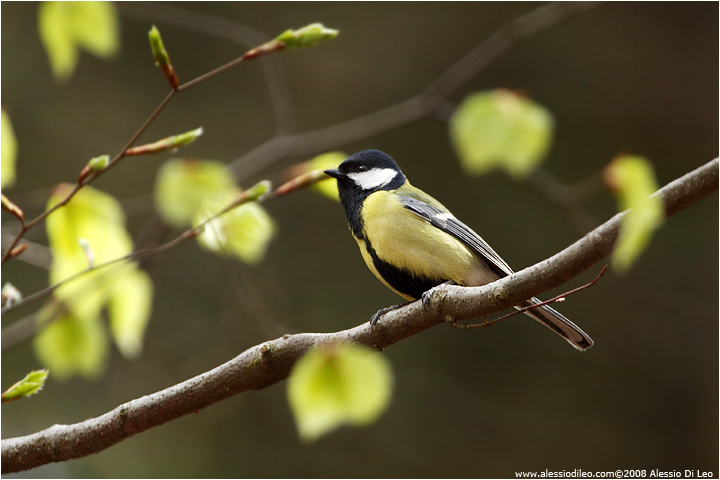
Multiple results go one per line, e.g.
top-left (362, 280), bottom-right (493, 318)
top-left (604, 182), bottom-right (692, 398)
top-left (450, 89), bottom-right (554, 178)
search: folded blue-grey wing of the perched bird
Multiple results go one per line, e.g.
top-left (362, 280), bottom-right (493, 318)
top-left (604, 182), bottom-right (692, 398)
top-left (398, 195), bottom-right (513, 277)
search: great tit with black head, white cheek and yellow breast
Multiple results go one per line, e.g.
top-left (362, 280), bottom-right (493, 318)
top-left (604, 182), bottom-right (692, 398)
top-left (325, 150), bottom-right (593, 350)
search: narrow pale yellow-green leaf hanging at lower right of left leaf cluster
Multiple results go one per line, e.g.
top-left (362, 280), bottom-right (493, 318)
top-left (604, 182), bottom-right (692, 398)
top-left (108, 270), bottom-right (153, 358)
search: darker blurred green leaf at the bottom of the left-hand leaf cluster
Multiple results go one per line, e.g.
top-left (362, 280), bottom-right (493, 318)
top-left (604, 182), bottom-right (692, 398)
top-left (33, 309), bottom-right (108, 380)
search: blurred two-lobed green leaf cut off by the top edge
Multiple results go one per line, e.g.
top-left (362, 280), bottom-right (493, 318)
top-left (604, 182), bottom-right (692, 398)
top-left (38, 2), bottom-right (120, 80)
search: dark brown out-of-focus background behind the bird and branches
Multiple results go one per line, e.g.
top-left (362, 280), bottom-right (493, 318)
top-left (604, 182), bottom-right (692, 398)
top-left (2, 2), bottom-right (718, 478)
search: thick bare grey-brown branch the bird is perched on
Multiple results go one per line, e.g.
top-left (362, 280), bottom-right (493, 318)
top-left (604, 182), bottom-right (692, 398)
top-left (2, 159), bottom-right (718, 473)
